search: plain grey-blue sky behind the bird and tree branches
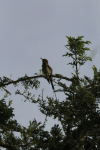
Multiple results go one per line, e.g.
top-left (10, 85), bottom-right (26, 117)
top-left (0, 0), bottom-right (100, 149)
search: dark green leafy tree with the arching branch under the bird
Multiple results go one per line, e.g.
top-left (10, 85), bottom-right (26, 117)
top-left (0, 36), bottom-right (100, 150)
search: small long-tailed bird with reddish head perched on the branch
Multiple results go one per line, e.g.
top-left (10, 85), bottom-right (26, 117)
top-left (41, 58), bottom-right (54, 90)
